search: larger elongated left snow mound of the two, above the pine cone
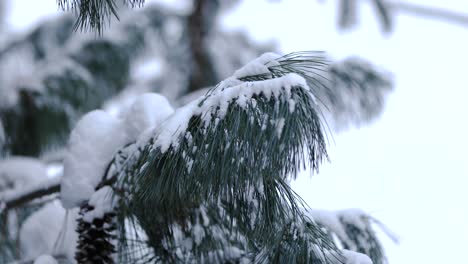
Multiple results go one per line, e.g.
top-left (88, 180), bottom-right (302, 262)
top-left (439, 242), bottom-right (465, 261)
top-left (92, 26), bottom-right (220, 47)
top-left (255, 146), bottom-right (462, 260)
top-left (60, 110), bottom-right (128, 209)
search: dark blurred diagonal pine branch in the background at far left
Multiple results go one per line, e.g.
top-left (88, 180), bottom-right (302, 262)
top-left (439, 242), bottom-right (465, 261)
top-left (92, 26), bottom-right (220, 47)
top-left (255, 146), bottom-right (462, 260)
top-left (0, 8), bottom-right (166, 156)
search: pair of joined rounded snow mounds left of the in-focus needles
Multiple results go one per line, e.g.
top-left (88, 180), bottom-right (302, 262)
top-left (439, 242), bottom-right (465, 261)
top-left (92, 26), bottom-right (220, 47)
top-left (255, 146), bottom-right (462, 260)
top-left (60, 93), bottom-right (174, 209)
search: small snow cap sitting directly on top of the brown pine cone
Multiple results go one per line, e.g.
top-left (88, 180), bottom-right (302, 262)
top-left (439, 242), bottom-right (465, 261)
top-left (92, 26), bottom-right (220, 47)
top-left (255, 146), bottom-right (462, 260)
top-left (83, 186), bottom-right (115, 223)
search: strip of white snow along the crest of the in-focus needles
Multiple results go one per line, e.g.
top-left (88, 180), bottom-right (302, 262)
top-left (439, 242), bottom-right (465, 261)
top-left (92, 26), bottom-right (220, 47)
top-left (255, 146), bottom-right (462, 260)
top-left (155, 73), bottom-right (309, 153)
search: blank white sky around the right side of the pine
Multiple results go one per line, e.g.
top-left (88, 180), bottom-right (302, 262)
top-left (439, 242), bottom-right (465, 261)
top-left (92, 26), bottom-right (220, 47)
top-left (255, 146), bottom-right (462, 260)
top-left (4, 0), bottom-right (468, 264)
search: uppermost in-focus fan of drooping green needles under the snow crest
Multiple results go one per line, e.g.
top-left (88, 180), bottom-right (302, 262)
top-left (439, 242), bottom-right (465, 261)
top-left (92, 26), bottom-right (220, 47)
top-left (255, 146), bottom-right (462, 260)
top-left (119, 51), bottom-right (326, 212)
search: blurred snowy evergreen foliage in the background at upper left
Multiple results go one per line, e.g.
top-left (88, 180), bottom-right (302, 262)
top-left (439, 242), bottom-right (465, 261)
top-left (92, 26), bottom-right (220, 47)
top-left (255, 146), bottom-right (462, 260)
top-left (0, 6), bottom-right (265, 156)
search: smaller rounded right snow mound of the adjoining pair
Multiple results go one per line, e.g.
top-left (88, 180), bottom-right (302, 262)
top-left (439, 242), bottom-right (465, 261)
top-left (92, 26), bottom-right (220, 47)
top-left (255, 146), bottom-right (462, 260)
top-left (123, 93), bottom-right (174, 141)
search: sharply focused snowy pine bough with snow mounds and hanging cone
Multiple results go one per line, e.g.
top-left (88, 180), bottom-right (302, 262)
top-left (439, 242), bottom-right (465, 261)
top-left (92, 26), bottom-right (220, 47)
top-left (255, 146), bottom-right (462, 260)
top-left (0, 52), bottom-right (394, 264)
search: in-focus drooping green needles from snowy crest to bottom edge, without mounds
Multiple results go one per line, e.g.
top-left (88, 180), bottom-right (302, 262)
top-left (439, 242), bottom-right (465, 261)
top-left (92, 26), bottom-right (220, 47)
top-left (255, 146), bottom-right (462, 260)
top-left (109, 52), bottom-right (354, 263)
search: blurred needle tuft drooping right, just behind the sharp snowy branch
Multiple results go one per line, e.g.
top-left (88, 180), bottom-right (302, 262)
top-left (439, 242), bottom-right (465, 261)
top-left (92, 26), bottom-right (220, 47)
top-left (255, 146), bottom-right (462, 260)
top-left (238, 52), bottom-right (393, 129)
